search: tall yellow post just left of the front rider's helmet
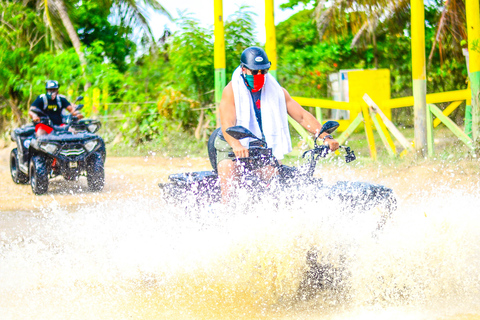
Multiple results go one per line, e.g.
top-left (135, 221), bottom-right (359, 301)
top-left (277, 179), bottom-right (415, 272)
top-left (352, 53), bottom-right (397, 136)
top-left (214, 0), bottom-right (227, 127)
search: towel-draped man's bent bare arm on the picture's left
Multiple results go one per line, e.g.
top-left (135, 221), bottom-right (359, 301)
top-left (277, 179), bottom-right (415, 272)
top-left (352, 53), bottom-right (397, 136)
top-left (219, 82), bottom-right (248, 158)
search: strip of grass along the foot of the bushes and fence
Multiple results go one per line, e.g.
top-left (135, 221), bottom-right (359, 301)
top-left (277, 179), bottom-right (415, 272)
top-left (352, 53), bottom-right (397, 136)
top-left (0, 120), bottom-right (478, 172)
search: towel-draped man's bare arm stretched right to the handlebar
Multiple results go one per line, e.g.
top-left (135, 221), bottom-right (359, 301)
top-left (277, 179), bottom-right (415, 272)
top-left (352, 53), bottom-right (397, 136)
top-left (282, 88), bottom-right (339, 151)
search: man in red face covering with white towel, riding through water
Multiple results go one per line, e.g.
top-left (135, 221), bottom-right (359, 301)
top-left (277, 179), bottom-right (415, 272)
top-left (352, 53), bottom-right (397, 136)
top-left (215, 47), bottom-right (339, 203)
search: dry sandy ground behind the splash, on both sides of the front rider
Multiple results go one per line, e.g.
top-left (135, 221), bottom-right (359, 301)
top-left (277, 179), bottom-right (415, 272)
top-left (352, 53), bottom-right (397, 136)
top-left (0, 147), bottom-right (480, 211)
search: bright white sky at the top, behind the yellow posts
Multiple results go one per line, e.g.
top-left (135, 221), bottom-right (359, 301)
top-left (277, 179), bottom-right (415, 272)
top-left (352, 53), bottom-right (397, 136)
top-left (150, 0), bottom-right (312, 44)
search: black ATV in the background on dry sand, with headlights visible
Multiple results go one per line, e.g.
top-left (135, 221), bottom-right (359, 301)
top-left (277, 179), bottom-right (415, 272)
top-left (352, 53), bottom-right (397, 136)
top-left (10, 97), bottom-right (106, 195)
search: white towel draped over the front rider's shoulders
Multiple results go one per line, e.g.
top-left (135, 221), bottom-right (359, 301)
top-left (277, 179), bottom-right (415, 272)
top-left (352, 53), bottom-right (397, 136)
top-left (232, 67), bottom-right (292, 160)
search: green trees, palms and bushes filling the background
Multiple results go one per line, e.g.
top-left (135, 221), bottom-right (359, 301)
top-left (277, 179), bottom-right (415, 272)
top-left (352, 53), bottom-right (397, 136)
top-left (0, 0), bottom-right (468, 156)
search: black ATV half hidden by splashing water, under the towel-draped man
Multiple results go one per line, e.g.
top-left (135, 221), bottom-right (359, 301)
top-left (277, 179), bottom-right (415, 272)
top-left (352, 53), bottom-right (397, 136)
top-left (159, 121), bottom-right (397, 228)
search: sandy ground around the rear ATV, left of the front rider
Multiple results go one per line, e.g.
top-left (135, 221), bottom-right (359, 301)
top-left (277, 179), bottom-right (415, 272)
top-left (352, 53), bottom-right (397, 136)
top-left (0, 149), bottom-right (210, 211)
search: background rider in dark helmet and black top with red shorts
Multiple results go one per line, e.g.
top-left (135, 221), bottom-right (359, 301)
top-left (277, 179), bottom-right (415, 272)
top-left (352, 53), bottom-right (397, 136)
top-left (28, 80), bottom-right (83, 137)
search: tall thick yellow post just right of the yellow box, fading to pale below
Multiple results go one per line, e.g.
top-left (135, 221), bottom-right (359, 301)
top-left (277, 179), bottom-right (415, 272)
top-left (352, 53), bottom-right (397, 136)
top-left (410, 0), bottom-right (426, 156)
